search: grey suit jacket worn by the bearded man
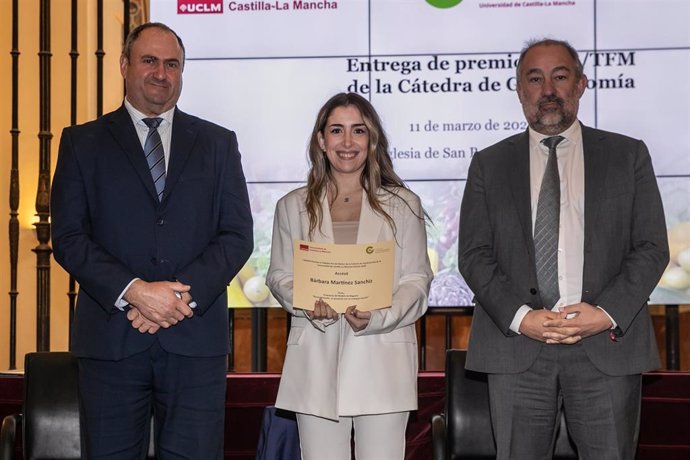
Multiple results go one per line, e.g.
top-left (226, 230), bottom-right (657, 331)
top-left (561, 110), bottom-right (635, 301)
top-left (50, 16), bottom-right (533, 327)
top-left (459, 126), bottom-right (669, 375)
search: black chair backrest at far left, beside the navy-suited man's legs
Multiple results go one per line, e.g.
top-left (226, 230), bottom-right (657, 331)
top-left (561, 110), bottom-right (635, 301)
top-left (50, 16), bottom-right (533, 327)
top-left (22, 352), bottom-right (81, 460)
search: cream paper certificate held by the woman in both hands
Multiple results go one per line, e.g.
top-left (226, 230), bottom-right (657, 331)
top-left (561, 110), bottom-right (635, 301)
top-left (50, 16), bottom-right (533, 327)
top-left (292, 240), bottom-right (395, 313)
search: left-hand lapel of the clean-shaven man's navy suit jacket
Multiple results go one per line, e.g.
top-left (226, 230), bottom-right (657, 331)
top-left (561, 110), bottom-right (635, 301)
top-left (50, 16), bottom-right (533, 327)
top-left (108, 105), bottom-right (158, 201)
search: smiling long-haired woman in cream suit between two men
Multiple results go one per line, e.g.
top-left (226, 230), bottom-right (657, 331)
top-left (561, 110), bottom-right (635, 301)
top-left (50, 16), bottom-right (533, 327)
top-left (267, 94), bottom-right (433, 460)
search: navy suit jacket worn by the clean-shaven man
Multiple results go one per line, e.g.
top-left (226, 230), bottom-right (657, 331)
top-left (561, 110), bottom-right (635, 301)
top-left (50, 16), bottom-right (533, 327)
top-left (51, 105), bottom-right (253, 360)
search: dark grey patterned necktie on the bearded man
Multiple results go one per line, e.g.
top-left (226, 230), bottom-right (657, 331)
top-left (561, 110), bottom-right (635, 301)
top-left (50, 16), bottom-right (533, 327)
top-left (534, 136), bottom-right (564, 309)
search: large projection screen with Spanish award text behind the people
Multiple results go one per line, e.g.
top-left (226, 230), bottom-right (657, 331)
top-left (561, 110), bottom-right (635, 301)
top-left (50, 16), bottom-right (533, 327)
top-left (150, 0), bottom-right (690, 307)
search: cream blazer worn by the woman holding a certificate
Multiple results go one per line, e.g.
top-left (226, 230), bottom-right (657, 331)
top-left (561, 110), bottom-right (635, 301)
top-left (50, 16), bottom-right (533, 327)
top-left (266, 187), bottom-right (433, 420)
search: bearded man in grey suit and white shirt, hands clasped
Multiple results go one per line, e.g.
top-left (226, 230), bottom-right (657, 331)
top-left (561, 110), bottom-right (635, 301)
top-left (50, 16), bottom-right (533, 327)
top-left (459, 40), bottom-right (669, 460)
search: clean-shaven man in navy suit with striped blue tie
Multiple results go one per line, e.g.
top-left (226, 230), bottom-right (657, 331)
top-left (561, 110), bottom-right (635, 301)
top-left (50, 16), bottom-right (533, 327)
top-left (51, 23), bottom-right (253, 460)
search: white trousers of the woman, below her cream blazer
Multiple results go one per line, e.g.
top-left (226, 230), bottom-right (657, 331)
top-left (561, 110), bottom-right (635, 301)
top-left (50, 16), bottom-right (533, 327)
top-left (297, 412), bottom-right (410, 460)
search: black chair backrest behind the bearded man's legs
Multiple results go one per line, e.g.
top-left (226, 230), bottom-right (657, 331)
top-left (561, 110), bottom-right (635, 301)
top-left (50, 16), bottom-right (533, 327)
top-left (445, 350), bottom-right (577, 460)
